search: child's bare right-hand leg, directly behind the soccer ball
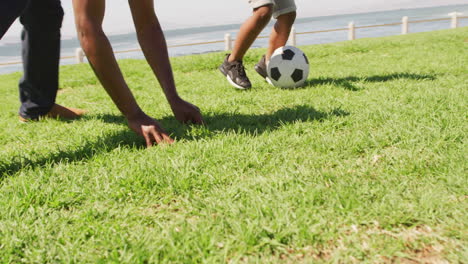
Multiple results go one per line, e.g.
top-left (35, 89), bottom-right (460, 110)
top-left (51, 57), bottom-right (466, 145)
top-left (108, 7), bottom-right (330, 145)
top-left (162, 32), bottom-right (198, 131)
top-left (266, 11), bottom-right (296, 61)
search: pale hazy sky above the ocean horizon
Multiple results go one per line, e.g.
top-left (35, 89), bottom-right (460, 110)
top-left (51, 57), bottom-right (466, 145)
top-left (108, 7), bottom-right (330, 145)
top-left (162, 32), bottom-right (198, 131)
top-left (4, 0), bottom-right (468, 40)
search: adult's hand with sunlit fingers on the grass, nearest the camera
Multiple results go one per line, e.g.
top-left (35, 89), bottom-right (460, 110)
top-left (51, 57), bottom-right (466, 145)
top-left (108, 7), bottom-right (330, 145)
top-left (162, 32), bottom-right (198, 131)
top-left (127, 112), bottom-right (174, 148)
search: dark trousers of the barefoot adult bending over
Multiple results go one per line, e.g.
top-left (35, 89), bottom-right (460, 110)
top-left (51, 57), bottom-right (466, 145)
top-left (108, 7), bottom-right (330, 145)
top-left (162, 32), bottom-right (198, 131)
top-left (0, 0), bottom-right (63, 119)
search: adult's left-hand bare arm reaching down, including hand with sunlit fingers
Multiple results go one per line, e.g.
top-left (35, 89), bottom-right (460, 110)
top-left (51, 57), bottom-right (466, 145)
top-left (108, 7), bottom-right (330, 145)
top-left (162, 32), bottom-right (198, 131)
top-left (73, 0), bottom-right (173, 147)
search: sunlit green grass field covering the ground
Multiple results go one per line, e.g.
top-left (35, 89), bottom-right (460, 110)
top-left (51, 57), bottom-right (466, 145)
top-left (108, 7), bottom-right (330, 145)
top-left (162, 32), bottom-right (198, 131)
top-left (0, 28), bottom-right (468, 263)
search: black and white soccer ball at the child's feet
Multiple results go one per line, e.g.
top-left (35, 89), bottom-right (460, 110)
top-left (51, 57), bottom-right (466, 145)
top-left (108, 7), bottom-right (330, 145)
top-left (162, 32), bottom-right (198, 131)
top-left (267, 46), bottom-right (309, 88)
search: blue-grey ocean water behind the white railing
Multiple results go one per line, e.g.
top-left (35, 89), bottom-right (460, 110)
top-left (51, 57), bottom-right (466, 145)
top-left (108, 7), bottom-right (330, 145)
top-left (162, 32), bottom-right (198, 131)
top-left (0, 5), bottom-right (468, 74)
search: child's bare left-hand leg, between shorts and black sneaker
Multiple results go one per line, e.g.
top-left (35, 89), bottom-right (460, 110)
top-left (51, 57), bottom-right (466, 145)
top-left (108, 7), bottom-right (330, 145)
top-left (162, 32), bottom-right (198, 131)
top-left (228, 5), bottom-right (273, 62)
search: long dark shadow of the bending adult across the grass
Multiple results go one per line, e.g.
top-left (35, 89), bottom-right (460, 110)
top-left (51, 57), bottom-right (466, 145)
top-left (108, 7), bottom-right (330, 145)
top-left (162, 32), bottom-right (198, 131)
top-left (0, 105), bottom-right (349, 177)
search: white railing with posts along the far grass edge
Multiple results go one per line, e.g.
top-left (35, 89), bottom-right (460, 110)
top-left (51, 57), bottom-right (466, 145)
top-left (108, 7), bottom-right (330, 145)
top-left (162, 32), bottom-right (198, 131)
top-left (0, 12), bottom-right (468, 66)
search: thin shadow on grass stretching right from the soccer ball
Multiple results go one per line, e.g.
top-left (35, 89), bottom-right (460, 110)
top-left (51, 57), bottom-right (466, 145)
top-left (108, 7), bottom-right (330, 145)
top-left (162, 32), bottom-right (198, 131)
top-left (304, 72), bottom-right (436, 91)
